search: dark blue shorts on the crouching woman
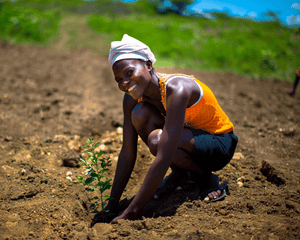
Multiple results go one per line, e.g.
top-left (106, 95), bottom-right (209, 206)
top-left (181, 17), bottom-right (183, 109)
top-left (191, 128), bottom-right (238, 172)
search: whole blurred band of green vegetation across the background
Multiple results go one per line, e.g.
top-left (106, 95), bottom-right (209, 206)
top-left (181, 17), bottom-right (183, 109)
top-left (0, 0), bottom-right (300, 81)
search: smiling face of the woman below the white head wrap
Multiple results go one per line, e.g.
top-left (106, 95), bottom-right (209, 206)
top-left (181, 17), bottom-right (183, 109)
top-left (113, 59), bottom-right (152, 99)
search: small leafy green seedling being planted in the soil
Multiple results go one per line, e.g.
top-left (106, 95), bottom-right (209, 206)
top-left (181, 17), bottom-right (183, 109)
top-left (78, 138), bottom-right (112, 217)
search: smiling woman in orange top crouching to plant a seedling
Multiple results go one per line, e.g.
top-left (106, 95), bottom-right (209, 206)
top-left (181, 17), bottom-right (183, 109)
top-left (94, 34), bottom-right (238, 223)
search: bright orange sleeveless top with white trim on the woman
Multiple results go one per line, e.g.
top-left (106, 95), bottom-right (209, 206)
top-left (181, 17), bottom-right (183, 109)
top-left (158, 73), bottom-right (234, 134)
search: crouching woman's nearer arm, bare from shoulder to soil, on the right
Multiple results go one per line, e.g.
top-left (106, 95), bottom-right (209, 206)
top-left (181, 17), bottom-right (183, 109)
top-left (112, 80), bottom-right (191, 223)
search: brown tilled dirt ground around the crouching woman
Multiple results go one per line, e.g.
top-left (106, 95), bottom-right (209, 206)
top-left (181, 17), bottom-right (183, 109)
top-left (0, 39), bottom-right (300, 240)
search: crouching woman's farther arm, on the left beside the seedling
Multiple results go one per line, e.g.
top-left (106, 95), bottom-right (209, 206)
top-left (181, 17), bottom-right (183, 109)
top-left (108, 94), bottom-right (138, 212)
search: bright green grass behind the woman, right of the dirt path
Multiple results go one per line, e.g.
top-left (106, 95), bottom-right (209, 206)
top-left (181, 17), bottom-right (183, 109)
top-left (88, 14), bottom-right (300, 79)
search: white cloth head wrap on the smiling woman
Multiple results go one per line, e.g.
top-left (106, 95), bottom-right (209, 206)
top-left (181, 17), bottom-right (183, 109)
top-left (108, 34), bottom-right (156, 67)
